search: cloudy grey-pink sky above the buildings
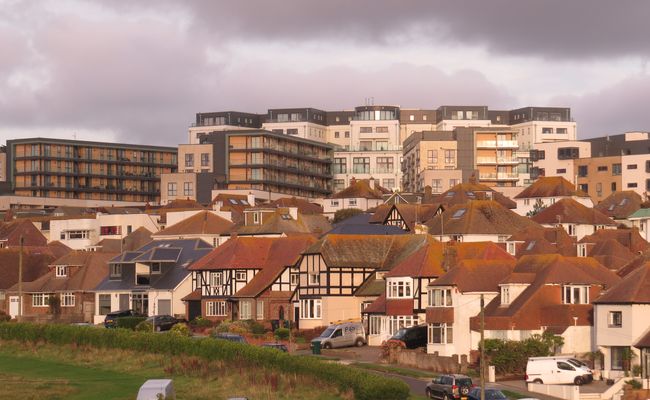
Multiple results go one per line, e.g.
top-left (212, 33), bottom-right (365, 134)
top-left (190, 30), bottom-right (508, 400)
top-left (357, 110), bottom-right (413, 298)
top-left (0, 0), bottom-right (650, 146)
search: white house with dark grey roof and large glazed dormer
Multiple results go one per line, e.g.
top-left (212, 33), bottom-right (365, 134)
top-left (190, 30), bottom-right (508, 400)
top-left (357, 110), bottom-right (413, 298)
top-left (93, 239), bottom-right (212, 323)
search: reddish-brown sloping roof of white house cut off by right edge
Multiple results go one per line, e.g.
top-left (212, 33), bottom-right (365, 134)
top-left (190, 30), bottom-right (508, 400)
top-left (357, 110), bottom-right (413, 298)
top-left (594, 263), bottom-right (650, 304)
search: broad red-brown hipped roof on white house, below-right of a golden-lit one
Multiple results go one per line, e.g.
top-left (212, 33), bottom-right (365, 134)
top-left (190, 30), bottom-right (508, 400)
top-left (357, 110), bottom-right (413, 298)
top-left (532, 198), bottom-right (616, 226)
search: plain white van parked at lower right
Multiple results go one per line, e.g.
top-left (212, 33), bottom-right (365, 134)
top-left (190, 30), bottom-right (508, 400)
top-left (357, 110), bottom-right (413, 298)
top-left (526, 356), bottom-right (593, 385)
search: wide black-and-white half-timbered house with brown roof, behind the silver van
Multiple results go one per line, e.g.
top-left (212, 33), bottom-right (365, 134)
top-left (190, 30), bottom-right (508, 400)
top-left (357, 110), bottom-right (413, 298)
top-left (297, 235), bottom-right (431, 329)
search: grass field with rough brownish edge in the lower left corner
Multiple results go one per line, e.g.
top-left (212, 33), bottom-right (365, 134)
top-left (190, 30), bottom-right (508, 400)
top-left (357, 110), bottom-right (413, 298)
top-left (0, 341), bottom-right (352, 400)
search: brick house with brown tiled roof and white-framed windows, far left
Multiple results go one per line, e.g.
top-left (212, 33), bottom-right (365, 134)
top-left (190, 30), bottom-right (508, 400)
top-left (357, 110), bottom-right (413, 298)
top-left (7, 250), bottom-right (117, 322)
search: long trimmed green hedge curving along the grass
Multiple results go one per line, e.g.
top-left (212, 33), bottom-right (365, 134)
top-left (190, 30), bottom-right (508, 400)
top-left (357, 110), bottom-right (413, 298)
top-left (0, 322), bottom-right (409, 400)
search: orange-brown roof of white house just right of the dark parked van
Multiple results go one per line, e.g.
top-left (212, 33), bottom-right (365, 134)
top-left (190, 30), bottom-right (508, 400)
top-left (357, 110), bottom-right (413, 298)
top-left (429, 258), bottom-right (516, 293)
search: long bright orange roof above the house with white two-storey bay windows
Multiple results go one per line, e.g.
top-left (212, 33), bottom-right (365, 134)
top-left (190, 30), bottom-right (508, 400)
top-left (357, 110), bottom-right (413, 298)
top-left (386, 239), bottom-right (514, 278)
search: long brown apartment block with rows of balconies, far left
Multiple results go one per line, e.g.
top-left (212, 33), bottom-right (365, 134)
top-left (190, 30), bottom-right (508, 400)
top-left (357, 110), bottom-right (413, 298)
top-left (6, 138), bottom-right (177, 203)
